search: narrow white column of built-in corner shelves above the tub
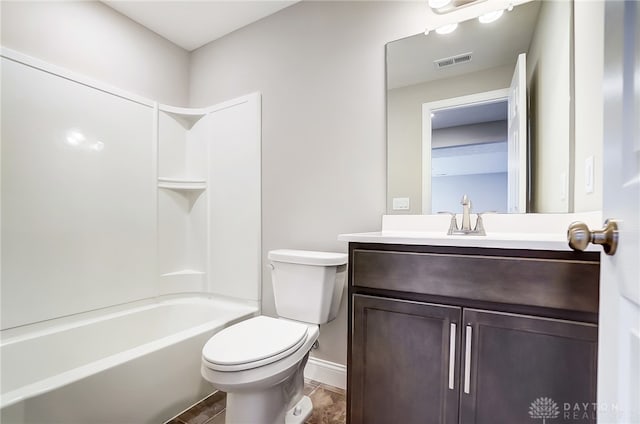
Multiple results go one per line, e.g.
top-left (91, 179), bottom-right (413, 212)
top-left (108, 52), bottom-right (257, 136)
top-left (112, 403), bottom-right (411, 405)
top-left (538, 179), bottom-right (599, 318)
top-left (157, 105), bottom-right (208, 294)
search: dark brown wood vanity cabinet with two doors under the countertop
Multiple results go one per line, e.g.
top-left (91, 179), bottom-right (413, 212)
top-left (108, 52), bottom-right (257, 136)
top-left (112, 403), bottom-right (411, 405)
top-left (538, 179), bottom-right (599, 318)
top-left (347, 242), bottom-right (600, 424)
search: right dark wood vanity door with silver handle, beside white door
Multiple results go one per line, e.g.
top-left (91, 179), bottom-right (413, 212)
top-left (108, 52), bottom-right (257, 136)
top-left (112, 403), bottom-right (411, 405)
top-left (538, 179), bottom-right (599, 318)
top-left (460, 309), bottom-right (598, 424)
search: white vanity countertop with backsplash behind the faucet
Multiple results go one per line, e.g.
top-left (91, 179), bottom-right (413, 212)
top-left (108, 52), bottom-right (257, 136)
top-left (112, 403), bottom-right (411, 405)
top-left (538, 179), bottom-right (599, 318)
top-left (338, 212), bottom-right (601, 252)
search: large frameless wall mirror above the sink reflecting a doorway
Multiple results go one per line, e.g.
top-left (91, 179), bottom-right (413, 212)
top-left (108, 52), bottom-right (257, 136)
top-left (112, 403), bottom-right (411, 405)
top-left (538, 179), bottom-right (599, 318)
top-left (386, 0), bottom-right (574, 214)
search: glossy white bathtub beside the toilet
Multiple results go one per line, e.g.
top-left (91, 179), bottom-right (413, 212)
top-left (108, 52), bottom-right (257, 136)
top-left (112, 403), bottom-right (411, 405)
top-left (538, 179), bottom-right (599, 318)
top-left (0, 296), bottom-right (258, 424)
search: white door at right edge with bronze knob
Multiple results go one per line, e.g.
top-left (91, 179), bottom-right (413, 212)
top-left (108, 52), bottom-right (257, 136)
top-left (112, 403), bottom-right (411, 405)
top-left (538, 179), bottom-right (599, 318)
top-left (597, 0), bottom-right (640, 424)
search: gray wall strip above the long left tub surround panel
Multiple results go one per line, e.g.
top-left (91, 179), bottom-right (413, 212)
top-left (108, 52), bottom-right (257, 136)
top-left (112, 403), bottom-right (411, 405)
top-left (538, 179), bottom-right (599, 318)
top-left (0, 1), bottom-right (189, 106)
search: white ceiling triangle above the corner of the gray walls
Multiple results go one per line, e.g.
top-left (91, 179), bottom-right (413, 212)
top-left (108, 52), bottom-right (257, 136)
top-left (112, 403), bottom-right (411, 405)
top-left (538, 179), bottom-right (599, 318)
top-left (103, 0), bottom-right (299, 51)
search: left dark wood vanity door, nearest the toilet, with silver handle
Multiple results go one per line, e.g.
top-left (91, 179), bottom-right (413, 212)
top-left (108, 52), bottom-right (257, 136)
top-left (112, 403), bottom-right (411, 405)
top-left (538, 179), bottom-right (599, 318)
top-left (350, 295), bottom-right (461, 424)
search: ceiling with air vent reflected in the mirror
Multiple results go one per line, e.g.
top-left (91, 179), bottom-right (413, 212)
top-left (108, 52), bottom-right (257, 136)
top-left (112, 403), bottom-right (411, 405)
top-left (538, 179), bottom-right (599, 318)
top-left (387, 1), bottom-right (540, 89)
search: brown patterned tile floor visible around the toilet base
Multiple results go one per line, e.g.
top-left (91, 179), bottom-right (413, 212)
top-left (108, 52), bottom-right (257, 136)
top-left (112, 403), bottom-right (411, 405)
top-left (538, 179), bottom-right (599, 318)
top-left (166, 380), bottom-right (347, 424)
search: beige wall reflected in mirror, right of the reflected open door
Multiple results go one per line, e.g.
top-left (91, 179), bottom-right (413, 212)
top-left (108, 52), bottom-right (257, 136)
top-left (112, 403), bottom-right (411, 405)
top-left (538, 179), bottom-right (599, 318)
top-left (527, 1), bottom-right (572, 213)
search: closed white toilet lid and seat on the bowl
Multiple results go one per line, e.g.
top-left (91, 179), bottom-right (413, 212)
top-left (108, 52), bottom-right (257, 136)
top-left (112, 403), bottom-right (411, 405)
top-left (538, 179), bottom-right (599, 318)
top-left (202, 316), bottom-right (308, 371)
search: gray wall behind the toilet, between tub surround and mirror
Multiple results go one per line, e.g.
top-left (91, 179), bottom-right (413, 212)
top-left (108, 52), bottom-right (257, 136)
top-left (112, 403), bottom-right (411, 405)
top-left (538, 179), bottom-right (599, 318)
top-left (191, 2), bottom-right (426, 364)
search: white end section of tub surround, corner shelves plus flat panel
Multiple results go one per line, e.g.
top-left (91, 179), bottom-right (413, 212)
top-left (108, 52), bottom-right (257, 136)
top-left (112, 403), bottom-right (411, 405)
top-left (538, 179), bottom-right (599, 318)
top-left (156, 93), bottom-right (262, 302)
